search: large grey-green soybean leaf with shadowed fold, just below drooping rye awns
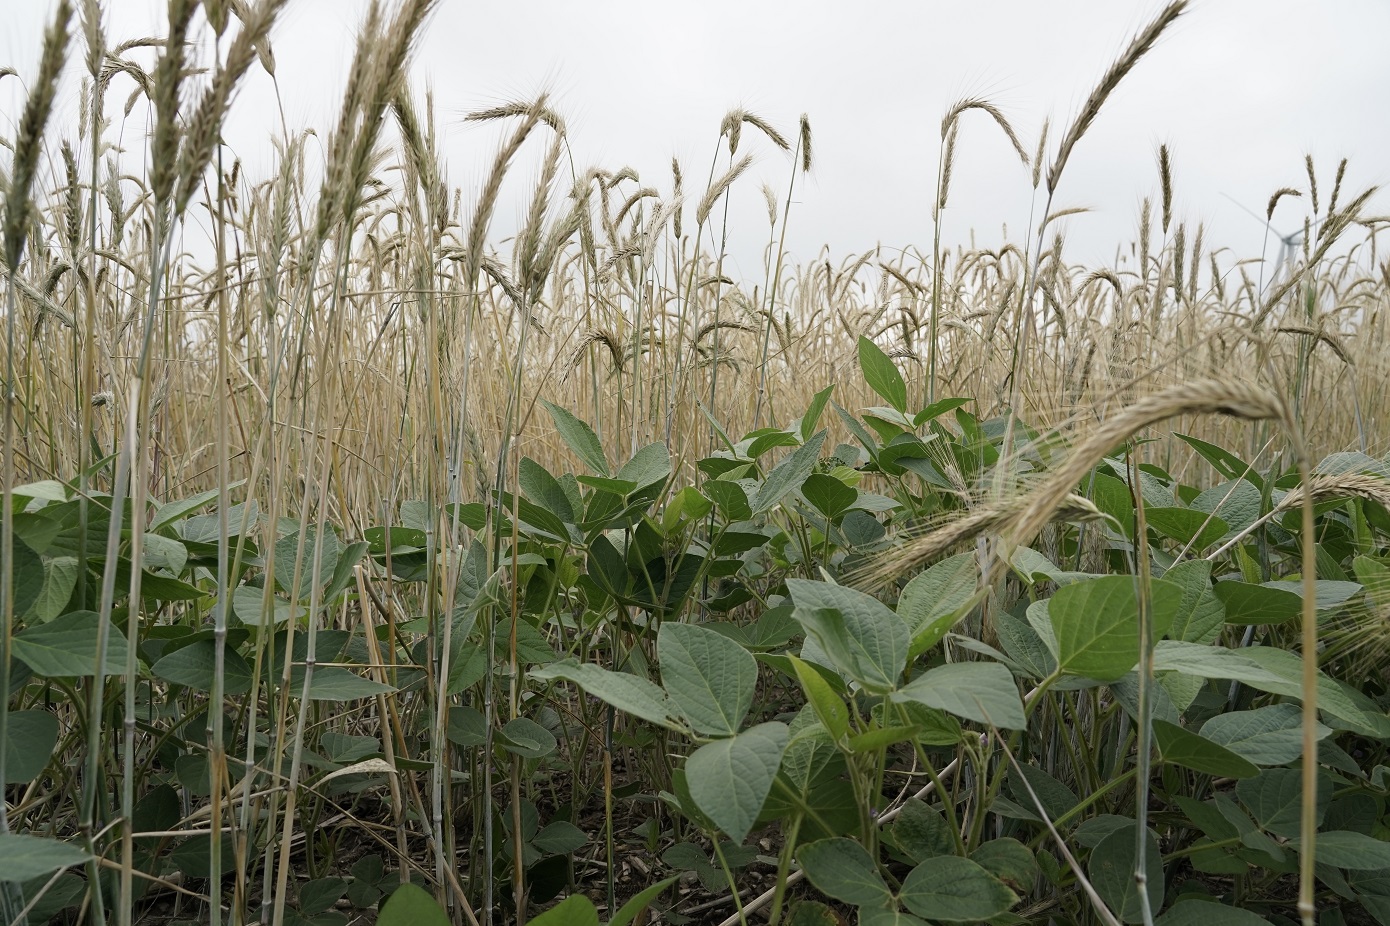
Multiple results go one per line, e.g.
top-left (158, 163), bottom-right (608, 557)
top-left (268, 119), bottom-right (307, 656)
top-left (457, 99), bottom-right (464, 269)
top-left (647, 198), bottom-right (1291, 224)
top-left (787, 578), bottom-right (909, 691)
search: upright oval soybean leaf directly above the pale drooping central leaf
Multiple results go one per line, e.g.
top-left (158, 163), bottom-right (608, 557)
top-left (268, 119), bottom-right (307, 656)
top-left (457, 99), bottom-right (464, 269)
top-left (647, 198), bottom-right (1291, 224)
top-left (656, 622), bottom-right (758, 737)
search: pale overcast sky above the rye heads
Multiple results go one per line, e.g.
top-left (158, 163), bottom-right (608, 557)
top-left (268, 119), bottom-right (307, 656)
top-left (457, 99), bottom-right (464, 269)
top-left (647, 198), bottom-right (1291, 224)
top-left (0, 0), bottom-right (1390, 281)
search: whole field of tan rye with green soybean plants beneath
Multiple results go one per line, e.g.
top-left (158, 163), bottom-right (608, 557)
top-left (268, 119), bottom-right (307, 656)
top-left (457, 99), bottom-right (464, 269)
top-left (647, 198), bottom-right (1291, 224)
top-left (0, 0), bottom-right (1390, 926)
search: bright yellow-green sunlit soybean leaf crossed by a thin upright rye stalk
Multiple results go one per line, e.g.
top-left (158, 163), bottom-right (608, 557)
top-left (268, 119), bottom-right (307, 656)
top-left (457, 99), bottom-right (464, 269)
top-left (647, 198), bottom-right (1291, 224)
top-left (1048, 576), bottom-right (1183, 681)
